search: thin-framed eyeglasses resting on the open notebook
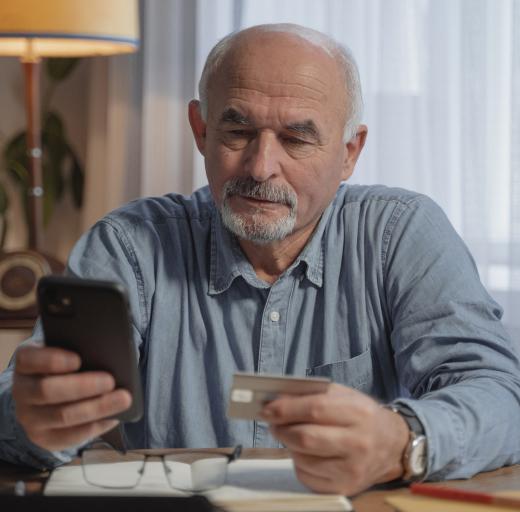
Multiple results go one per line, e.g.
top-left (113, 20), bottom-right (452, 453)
top-left (79, 441), bottom-right (242, 492)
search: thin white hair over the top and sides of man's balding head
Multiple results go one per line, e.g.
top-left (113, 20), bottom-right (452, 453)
top-left (199, 24), bottom-right (363, 141)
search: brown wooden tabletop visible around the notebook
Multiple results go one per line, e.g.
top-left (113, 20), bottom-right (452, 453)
top-left (0, 448), bottom-right (520, 512)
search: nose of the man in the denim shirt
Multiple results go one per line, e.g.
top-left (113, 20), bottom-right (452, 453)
top-left (245, 133), bottom-right (282, 181)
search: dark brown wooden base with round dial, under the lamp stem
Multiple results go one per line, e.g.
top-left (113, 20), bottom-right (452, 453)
top-left (0, 250), bottom-right (65, 329)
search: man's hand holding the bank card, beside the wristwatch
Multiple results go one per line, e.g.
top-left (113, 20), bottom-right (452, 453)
top-left (262, 384), bottom-right (409, 495)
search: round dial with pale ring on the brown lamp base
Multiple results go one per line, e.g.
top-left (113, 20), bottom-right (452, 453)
top-left (0, 252), bottom-right (50, 311)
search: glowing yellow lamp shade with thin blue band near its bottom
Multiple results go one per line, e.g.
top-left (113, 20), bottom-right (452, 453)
top-left (0, 0), bottom-right (139, 60)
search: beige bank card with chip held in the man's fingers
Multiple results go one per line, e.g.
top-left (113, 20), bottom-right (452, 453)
top-left (227, 373), bottom-right (331, 420)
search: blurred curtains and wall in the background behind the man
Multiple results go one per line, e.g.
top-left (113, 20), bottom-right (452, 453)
top-left (0, 0), bottom-right (520, 367)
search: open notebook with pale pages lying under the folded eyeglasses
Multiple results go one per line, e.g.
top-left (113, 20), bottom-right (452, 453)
top-left (44, 459), bottom-right (353, 512)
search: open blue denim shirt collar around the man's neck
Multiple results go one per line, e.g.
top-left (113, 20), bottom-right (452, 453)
top-left (208, 201), bottom-right (332, 295)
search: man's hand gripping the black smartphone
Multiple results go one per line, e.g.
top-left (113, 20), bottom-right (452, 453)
top-left (13, 347), bottom-right (132, 451)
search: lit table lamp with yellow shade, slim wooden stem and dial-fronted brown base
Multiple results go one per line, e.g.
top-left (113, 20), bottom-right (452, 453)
top-left (0, 0), bottom-right (139, 328)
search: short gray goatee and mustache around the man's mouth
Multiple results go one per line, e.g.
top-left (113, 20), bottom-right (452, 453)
top-left (220, 178), bottom-right (298, 245)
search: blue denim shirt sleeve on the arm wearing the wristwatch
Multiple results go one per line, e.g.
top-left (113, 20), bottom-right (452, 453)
top-left (383, 197), bottom-right (520, 479)
